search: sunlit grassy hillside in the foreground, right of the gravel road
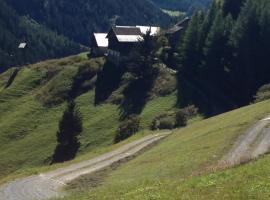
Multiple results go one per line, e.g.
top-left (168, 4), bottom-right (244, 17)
top-left (59, 101), bottom-right (270, 200)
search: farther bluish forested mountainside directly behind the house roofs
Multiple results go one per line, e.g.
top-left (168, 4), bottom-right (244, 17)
top-left (6, 0), bottom-right (169, 45)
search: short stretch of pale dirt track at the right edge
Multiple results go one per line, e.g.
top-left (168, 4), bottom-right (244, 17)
top-left (220, 116), bottom-right (270, 167)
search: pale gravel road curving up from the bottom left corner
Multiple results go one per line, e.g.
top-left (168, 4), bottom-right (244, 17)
top-left (0, 133), bottom-right (169, 200)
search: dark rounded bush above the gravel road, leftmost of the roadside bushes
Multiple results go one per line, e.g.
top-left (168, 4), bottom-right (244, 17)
top-left (114, 115), bottom-right (140, 143)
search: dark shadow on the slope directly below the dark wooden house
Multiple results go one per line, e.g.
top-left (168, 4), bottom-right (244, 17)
top-left (95, 61), bottom-right (124, 105)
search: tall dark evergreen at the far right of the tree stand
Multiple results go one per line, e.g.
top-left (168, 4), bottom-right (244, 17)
top-left (231, 0), bottom-right (270, 104)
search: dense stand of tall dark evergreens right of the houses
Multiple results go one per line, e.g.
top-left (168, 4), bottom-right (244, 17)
top-left (175, 0), bottom-right (270, 111)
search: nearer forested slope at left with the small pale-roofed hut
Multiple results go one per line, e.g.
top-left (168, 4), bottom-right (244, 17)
top-left (0, 0), bottom-right (80, 72)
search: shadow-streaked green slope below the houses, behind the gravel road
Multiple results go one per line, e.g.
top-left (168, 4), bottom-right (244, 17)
top-left (0, 54), bottom-right (176, 182)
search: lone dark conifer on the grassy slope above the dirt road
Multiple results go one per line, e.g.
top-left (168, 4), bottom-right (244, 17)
top-left (52, 100), bottom-right (83, 163)
